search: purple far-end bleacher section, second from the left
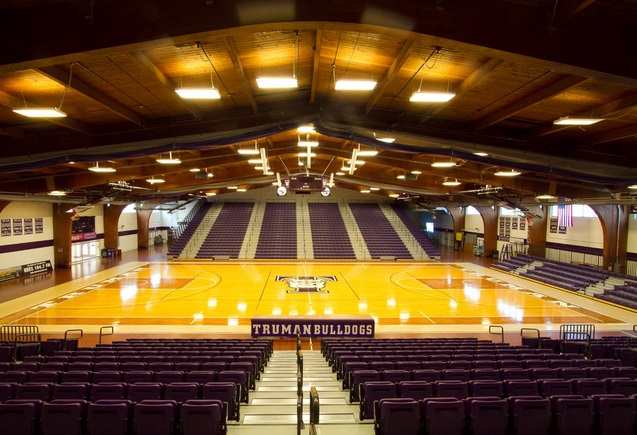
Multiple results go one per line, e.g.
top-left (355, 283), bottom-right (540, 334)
top-left (195, 202), bottom-right (254, 258)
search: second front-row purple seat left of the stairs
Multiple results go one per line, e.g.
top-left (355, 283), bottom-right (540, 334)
top-left (133, 400), bottom-right (177, 435)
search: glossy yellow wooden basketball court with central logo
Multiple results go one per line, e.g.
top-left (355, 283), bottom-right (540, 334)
top-left (0, 261), bottom-right (636, 335)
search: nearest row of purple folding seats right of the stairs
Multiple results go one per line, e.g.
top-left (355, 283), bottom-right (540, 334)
top-left (374, 394), bottom-right (637, 435)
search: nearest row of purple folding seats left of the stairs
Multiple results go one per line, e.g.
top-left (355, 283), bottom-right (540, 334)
top-left (0, 399), bottom-right (227, 435)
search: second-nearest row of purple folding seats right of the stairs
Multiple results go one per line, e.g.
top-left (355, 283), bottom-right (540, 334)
top-left (349, 372), bottom-right (637, 406)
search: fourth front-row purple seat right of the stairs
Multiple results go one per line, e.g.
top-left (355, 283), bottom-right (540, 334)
top-left (509, 396), bottom-right (551, 435)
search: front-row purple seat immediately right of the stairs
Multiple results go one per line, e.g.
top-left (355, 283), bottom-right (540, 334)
top-left (374, 398), bottom-right (420, 435)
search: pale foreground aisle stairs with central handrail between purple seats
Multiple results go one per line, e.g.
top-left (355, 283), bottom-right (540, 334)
top-left (228, 350), bottom-right (374, 435)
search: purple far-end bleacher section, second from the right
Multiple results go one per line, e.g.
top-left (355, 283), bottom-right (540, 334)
top-left (349, 203), bottom-right (413, 259)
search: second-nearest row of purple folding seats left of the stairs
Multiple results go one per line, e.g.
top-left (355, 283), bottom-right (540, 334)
top-left (0, 382), bottom-right (243, 420)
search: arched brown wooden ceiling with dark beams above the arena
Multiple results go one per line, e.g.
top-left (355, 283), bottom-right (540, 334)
top-left (0, 0), bottom-right (637, 211)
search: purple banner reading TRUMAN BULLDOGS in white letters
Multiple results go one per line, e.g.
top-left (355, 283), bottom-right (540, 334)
top-left (251, 317), bottom-right (375, 338)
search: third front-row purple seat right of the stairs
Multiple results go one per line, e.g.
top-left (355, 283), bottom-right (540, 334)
top-left (466, 397), bottom-right (508, 435)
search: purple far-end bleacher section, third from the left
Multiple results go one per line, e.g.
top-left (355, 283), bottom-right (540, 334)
top-left (254, 202), bottom-right (297, 259)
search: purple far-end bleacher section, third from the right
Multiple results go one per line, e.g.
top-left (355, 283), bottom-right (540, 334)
top-left (308, 202), bottom-right (356, 259)
